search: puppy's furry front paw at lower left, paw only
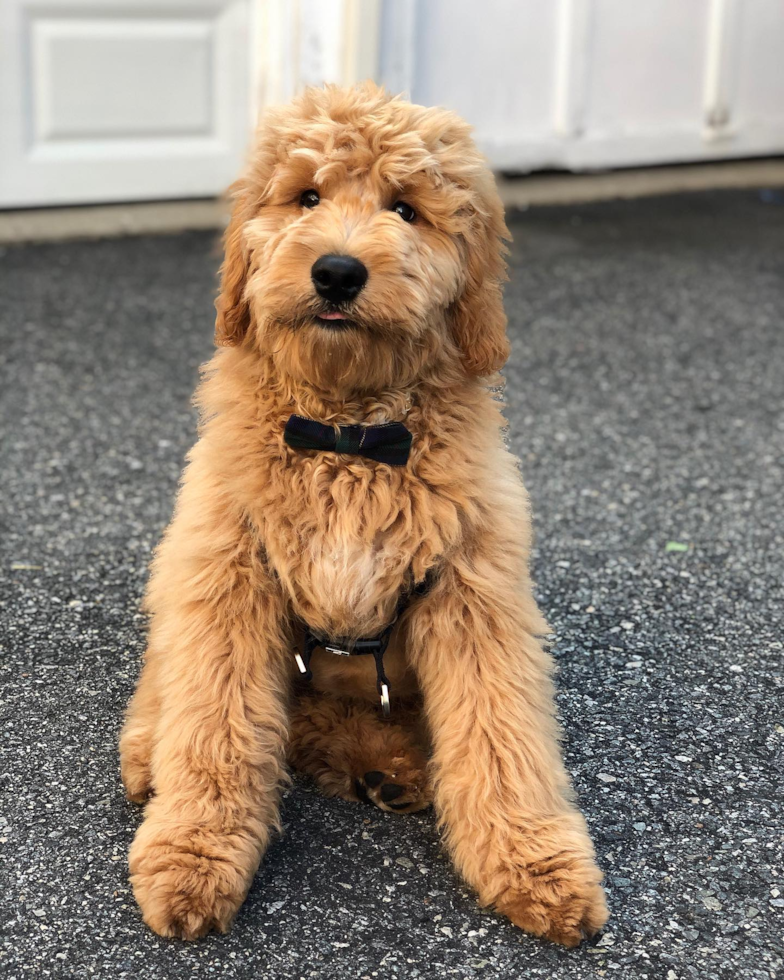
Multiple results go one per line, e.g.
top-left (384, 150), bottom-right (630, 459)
top-left (129, 827), bottom-right (250, 939)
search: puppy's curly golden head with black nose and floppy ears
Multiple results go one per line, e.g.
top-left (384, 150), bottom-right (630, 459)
top-left (216, 84), bottom-right (508, 389)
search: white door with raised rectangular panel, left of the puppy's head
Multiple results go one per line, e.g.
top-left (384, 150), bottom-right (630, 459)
top-left (0, 0), bottom-right (252, 207)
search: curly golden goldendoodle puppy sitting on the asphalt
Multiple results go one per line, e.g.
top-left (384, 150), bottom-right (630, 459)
top-left (121, 85), bottom-right (607, 945)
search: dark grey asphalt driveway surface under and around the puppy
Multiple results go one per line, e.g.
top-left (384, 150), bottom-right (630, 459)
top-left (0, 192), bottom-right (784, 980)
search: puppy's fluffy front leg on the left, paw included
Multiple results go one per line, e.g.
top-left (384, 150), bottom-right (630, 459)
top-left (129, 487), bottom-right (287, 939)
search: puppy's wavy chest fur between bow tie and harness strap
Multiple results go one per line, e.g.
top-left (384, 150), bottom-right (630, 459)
top-left (263, 456), bottom-right (443, 637)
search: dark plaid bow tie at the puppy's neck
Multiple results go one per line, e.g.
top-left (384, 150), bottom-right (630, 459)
top-left (283, 415), bottom-right (411, 466)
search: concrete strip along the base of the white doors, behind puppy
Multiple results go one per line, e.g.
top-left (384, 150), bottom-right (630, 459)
top-left (0, 158), bottom-right (784, 244)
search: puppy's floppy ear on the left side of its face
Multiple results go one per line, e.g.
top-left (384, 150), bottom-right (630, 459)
top-left (215, 181), bottom-right (250, 347)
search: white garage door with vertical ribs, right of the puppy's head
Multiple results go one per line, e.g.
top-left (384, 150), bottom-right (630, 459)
top-left (380, 0), bottom-right (784, 171)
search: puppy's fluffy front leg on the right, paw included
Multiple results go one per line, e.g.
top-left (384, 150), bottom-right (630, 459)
top-left (411, 546), bottom-right (607, 946)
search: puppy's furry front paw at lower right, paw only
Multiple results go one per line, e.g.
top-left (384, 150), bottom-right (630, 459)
top-left (495, 852), bottom-right (608, 946)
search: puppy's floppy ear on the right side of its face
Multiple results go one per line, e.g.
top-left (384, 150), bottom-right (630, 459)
top-left (451, 172), bottom-right (509, 376)
